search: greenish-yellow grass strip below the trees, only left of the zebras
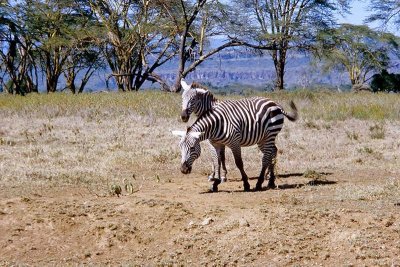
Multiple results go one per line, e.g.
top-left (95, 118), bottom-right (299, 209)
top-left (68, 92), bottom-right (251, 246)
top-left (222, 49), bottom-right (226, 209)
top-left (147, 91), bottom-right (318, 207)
top-left (0, 91), bottom-right (181, 118)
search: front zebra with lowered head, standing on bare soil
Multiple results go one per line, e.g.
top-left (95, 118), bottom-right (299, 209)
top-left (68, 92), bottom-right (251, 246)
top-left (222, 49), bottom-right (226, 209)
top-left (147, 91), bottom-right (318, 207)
top-left (172, 97), bottom-right (298, 192)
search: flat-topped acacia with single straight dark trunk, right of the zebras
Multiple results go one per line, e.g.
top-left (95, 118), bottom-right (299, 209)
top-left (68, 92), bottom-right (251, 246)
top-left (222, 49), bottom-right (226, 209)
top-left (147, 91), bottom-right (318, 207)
top-left (230, 0), bottom-right (349, 90)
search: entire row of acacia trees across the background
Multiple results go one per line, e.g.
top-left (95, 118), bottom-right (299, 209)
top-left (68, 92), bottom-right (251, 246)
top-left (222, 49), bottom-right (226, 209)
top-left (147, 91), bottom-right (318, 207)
top-left (0, 0), bottom-right (400, 94)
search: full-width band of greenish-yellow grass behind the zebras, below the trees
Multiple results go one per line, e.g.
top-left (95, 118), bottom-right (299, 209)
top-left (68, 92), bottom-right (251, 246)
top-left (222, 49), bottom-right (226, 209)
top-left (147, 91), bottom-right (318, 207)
top-left (0, 90), bottom-right (400, 122)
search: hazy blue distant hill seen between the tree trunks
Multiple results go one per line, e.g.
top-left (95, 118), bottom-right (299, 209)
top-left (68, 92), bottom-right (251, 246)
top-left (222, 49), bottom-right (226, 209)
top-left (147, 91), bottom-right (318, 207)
top-left (79, 46), bottom-right (400, 91)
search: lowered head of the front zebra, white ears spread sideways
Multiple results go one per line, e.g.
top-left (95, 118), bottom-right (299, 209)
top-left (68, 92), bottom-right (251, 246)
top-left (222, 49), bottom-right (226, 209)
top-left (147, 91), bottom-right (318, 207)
top-left (172, 131), bottom-right (202, 174)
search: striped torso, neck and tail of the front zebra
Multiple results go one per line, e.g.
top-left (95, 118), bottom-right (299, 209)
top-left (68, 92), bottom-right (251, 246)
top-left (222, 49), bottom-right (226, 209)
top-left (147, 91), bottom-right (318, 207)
top-left (189, 97), bottom-right (298, 146)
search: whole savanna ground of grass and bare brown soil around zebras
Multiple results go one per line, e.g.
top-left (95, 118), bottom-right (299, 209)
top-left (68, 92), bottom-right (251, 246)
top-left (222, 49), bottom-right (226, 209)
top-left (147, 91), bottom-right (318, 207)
top-left (0, 91), bottom-right (400, 266)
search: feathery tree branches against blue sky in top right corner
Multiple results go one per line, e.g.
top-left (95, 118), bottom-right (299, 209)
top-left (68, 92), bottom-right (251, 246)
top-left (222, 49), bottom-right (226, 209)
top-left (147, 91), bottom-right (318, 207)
top-left (366, 0), bottom-right (400, 28)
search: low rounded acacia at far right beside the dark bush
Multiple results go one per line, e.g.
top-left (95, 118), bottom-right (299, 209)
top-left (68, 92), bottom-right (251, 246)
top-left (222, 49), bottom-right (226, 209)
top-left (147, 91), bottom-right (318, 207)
top-left (316, 24), bottom-right (400, 88)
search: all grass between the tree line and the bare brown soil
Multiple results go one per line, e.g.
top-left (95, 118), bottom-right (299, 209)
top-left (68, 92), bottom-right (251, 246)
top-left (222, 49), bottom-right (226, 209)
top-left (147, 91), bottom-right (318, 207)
top-left (0, 91), bottom-right (400, 191)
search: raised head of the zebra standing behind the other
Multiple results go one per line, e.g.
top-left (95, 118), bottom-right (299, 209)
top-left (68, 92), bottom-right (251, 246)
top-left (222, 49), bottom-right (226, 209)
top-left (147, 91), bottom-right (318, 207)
top-left (181, 79), bottom-right (207, 122)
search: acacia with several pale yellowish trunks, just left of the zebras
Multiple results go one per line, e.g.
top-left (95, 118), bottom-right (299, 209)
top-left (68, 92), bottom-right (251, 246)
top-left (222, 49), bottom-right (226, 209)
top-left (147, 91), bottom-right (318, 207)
top-left (89, 0), bottom-right (177, 91)
